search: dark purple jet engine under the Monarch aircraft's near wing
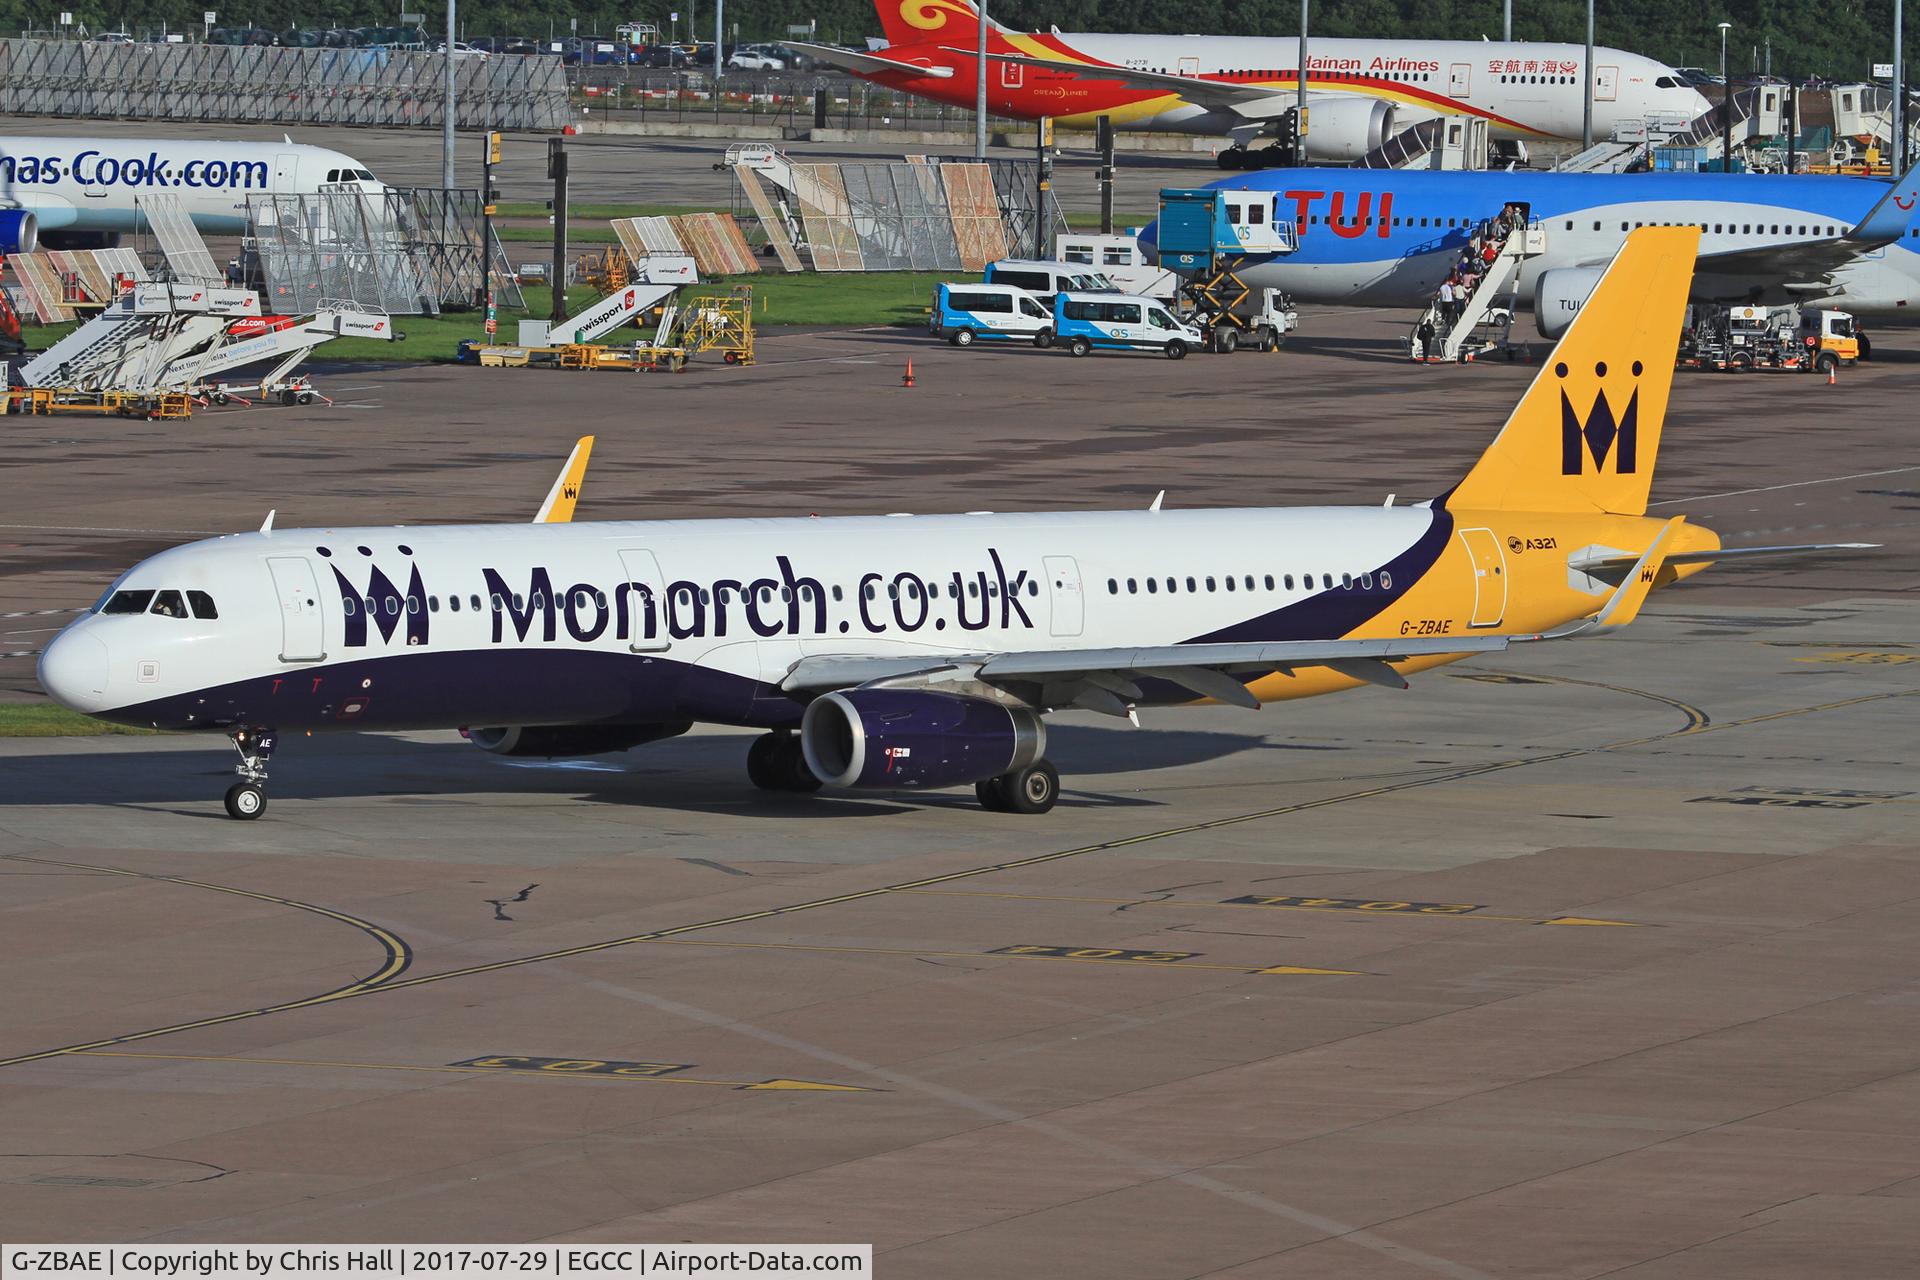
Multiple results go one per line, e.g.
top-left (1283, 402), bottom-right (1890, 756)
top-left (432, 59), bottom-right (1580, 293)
top-left (801, 689), bottom-right (1046, 787)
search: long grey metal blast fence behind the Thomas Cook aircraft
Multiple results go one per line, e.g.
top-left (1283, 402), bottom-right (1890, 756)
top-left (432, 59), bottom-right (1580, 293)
top-left (0, 40), bottom-right (572, 130)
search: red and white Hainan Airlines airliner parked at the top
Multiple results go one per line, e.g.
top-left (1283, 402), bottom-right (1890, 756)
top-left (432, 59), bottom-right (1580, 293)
top-left (789, 0), bottom-right (1709, 169)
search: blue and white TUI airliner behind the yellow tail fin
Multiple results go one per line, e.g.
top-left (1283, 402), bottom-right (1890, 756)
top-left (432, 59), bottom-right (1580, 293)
top-left (1140, 169), bottom-right (1920, 338)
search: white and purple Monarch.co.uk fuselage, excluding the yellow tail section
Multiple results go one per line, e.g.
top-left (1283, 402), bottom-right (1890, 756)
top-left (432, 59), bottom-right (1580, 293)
top-left (40, 507), bottom-right (1473, 729)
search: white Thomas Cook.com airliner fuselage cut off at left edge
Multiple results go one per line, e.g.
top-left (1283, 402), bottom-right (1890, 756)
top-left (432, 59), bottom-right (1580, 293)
top-left (0, 136), bottom-right (386, 234)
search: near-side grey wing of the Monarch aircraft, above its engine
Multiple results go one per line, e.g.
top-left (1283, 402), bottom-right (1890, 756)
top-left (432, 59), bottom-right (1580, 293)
top-left (780, 635), bottom-right (1530, 716)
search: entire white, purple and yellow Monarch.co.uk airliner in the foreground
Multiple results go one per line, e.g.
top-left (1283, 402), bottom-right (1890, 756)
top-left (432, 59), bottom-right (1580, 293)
top-left (40, 226), bottom-right (1873, 818)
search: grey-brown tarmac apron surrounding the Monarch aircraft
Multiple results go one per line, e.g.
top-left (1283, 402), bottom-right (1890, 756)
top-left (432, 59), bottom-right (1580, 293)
top-left (0, 311), bottom-right (1920, 1280)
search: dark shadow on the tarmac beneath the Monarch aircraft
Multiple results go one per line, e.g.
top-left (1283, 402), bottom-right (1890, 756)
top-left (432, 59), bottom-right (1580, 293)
top-left (0, 725), bottom-right (1344, 821)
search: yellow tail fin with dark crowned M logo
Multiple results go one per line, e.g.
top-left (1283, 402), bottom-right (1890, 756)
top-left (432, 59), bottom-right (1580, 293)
top-left (1446, 226), bottom-right (1699, 516)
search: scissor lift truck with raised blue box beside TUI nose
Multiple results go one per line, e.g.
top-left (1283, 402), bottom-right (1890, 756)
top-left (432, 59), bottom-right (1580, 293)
top-left (1160, 186), bottom-right (1300, 353)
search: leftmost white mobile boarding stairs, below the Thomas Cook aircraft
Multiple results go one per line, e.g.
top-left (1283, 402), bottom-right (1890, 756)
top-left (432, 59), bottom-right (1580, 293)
top-left (17, 284), bottom-right (259, 393)
